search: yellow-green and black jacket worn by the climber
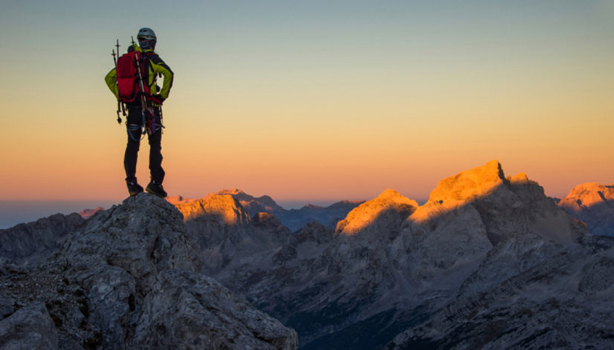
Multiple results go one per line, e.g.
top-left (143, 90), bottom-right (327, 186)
top-left (104, 44), bottom-right (174, 100)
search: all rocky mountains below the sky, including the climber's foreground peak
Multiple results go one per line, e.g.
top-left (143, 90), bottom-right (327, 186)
top-left (0, 161), bottom-right (614, 350)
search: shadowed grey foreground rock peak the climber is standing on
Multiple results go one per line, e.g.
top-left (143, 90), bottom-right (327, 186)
top-left (0, 194), bottom-right (297, 349)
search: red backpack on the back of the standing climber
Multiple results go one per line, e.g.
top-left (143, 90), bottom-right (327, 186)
top-left (117, 51), bottom-right (150, 103)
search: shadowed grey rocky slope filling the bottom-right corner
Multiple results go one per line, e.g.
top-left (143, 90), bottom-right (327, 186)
top-left (386, 238), bottom-right (614, 350)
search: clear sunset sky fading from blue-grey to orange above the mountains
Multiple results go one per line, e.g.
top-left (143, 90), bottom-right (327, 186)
top-left (0, 0), bottom-right (614, 202)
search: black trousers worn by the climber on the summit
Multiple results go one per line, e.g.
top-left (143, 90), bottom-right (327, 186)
top-left (124, 105), bottom-right (164, 184)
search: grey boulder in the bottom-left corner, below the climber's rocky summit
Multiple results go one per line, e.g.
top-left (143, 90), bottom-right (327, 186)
top-left (0, 303), bottom-right (58, 350)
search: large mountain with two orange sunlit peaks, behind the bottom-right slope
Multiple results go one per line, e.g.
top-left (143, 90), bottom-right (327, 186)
top-left (199, 161), bottom-right (610, 349)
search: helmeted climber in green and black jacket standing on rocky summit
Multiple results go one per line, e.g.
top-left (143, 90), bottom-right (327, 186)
top-left (105, 28), bottom-right (174, 198)
